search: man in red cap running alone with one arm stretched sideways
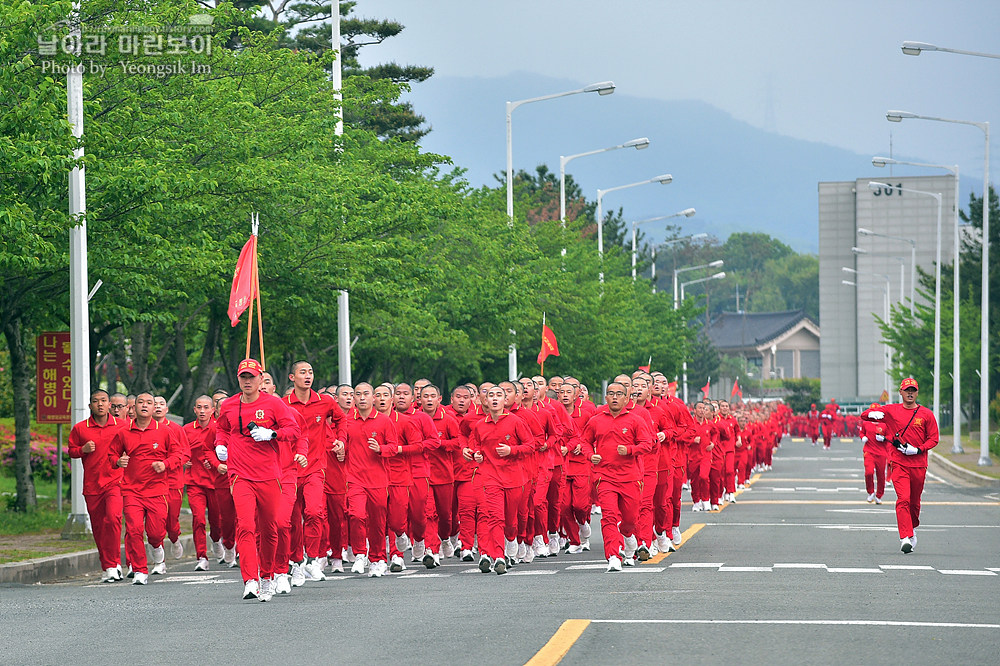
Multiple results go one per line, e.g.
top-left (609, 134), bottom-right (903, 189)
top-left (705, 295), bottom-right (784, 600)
top-left (861, 377), bottom-right (938, 553)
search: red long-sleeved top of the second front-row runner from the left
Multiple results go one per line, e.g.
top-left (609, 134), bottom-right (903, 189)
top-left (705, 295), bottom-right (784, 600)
top-left (108, 419), bottom-right (183, 497)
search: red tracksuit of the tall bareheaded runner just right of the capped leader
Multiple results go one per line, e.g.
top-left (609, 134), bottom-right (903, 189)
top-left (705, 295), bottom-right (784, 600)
top-left (284, 389), bottom-right (344, 562)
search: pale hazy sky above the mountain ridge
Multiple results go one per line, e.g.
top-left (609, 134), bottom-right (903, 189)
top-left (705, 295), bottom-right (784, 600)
top-left (356, 0), bottom-right (1000, 182)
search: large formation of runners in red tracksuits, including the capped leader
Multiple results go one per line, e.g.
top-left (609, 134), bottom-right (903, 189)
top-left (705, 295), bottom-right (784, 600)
top-left (70, 359), bottom-right (790, 601)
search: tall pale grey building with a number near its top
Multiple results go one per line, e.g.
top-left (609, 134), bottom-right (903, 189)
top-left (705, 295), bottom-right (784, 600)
top-left (819, 174), bottom-right (955, 401)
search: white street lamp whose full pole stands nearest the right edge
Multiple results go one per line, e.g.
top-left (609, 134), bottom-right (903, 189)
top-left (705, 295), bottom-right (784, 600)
top-left (885, 109), bottom-right (993, 466)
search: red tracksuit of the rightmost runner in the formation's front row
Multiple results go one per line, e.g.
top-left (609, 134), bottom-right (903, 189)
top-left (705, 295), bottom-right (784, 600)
top-left (581, 410), bottom-right (653, 559)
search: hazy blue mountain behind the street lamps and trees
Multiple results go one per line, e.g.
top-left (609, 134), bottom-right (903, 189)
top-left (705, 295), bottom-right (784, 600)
top-left (404, 72), bottom-right (965, 253)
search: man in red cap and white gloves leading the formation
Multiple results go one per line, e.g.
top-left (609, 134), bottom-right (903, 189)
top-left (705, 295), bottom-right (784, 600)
top-left (215, 358), bottom-right (306, 601)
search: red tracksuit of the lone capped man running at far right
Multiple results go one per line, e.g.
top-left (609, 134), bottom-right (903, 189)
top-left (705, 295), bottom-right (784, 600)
top-left (861, 403), bottom-right (938, 539)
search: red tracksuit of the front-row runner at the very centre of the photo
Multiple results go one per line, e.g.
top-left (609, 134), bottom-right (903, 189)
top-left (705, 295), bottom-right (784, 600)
top-left (469, 412), bottom-right (535, 559)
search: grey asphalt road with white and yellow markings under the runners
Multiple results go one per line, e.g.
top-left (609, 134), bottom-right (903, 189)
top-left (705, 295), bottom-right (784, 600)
top-left (0, 439), bottom-right (1000, 665)
